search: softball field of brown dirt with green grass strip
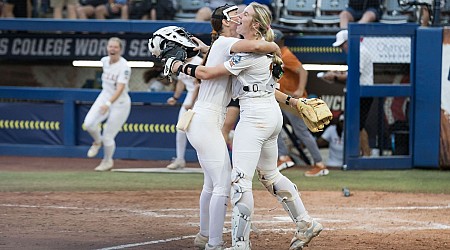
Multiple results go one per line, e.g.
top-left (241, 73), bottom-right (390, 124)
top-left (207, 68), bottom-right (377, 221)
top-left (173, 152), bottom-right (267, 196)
top-left (0, 156), bottom-right (450, 250)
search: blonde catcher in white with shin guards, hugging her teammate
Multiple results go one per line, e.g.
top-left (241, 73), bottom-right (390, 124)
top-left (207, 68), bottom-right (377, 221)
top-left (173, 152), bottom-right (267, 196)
top-left (169, 3), bottom-right (323, 250)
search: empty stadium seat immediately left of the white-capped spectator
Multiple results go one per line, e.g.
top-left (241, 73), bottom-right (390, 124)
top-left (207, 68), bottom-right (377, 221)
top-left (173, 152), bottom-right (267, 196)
top-left (312, 0), bottom-right (348, 25)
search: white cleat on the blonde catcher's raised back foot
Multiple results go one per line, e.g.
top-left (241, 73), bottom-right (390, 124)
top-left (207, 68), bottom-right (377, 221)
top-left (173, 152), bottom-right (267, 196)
top-left (289, 219), bottom-right (323, 250)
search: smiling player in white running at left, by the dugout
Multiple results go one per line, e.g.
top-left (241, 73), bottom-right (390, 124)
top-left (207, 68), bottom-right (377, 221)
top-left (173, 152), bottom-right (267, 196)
top-left (84, 37), bottom-right (131, 171)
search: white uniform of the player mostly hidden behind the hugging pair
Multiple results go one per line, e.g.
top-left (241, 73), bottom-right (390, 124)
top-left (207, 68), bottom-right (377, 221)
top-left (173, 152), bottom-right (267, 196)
top-left (176, 56), bottom-right (203, 160)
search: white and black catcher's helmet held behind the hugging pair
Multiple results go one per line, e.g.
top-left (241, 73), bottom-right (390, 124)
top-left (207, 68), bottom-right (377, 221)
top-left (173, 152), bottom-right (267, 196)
top-left (148, 26), bottom-right (199, 58)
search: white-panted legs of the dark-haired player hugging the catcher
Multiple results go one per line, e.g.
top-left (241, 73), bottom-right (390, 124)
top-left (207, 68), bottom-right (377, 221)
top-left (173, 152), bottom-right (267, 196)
top-left (186, 103), bottom-right (231, 247)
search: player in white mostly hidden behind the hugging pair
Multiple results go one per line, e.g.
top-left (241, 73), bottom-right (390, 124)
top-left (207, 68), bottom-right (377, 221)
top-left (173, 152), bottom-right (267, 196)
top-left (167, 56), bottom-right (203, 170)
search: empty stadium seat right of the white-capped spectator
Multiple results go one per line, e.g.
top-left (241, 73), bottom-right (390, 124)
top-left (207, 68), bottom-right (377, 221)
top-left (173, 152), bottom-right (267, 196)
top-left (380, 0), bottom-right (416, 24)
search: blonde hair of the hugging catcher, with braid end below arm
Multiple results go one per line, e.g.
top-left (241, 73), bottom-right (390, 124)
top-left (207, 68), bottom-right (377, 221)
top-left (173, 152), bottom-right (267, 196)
top-left (250, 2), bottom-right (283, 64)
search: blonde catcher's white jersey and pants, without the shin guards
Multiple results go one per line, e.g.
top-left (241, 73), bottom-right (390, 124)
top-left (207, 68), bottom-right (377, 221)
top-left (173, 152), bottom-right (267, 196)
top-left (224, 53), bottom-right (283, 190)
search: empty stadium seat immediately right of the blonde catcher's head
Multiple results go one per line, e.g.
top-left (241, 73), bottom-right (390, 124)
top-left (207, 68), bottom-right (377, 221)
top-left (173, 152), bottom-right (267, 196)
top-left (279, 0), bottom-right (316, 25)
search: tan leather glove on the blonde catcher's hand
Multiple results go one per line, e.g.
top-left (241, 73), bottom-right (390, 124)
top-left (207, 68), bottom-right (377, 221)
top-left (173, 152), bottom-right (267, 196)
top-left (297, 98), bottom-right (333, 132)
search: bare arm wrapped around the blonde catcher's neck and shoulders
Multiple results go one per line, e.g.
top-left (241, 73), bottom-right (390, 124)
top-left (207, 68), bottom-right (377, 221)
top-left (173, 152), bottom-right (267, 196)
top-left (231, 39), bottom-right (281, 56)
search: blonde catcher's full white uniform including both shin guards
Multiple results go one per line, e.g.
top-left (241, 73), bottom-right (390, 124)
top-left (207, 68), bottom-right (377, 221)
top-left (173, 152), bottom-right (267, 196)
top-left (224, 53), bottom-right (308, 249)
